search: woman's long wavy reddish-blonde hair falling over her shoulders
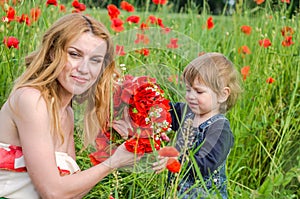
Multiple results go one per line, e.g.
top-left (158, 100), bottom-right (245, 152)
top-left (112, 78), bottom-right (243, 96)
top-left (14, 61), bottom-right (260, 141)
top-left (13, 13), bottom-right (117, 146)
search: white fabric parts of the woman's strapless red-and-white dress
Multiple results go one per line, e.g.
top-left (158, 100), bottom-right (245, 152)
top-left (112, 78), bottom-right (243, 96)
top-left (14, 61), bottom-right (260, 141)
top-left (0, 143), bottom-right (80, 199)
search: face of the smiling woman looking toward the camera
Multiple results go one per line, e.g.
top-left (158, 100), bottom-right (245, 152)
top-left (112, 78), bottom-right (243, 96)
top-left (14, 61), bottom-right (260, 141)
top-left (58, 32), bottom-right (107, 95)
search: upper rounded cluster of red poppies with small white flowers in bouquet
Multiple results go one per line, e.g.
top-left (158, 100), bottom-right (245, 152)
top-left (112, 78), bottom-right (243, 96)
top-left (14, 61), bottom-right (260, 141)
top-left (114, 75), bottom-right (171, 155)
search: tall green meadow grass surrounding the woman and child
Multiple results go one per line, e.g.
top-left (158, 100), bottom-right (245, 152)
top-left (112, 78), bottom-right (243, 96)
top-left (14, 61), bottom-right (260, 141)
top-left (0, 1), bottom-right (300, 199)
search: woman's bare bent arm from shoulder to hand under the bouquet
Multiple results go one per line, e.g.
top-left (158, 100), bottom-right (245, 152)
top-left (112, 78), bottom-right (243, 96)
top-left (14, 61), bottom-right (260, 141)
top-left (12, 88), bottom-right (134, 198)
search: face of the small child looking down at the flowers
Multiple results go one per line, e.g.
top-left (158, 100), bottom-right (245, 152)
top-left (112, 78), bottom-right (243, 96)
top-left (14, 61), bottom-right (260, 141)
top-left (185, 79), bottom-right (220, 117)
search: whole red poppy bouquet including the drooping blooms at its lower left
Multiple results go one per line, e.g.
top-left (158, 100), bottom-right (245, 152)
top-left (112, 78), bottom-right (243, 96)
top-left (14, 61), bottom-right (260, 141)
top-left (90, 75), bottom-right (182, 171)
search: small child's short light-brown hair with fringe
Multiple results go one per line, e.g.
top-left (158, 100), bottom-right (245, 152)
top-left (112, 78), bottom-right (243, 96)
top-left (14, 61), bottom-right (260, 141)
top-left (183, 52), bottom-right (242, 113)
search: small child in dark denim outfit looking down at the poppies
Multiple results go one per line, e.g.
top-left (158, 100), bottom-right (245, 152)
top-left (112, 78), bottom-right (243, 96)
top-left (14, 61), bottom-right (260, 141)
top-left (154, 53), bottom-right (241, 199)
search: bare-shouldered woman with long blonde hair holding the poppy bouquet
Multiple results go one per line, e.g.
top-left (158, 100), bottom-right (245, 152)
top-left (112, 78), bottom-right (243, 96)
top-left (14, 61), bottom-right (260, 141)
top-left (0, 13), bottom-right (135, 199)
